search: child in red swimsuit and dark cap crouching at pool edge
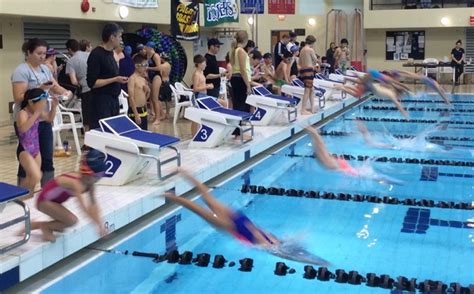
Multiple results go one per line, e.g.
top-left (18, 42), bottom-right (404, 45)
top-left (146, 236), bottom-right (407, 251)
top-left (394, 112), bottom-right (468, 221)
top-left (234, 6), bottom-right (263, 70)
top-left (31, 149), bottom-right (106, 242)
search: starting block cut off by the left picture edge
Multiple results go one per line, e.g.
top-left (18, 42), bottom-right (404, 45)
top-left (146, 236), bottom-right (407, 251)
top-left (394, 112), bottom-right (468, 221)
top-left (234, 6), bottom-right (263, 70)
top-left (0, 182), bottom-right (31, 254)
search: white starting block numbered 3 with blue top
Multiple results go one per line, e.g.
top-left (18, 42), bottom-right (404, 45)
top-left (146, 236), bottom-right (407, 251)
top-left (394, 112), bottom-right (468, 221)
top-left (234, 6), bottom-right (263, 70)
top-left (184, 96), bottom-right (253, 147)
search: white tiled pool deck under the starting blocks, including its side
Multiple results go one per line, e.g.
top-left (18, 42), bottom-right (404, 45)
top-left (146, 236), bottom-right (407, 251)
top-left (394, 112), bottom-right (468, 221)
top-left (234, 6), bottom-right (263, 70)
top-left (0, 97), bottom-right (358, 291)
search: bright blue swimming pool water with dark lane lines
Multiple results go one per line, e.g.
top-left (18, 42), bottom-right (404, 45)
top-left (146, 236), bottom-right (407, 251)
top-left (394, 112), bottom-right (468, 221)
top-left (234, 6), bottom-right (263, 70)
top-left (43, 95), bottom-right (474, 293)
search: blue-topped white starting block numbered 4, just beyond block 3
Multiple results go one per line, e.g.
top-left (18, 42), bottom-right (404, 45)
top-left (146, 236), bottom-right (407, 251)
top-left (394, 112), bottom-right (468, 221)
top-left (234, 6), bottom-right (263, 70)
top-left (245, 86), bottom-right (299, 126)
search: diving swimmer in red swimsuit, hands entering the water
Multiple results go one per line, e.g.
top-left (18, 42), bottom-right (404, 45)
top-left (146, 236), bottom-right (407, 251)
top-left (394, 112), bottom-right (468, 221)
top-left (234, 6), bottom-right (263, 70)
top-left (305, 126), bottom-right (403, 185)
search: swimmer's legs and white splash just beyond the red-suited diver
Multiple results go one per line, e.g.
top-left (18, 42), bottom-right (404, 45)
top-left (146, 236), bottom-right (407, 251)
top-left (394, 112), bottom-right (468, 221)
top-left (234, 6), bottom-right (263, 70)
top-left (356, 120), bottom-right (446, 152)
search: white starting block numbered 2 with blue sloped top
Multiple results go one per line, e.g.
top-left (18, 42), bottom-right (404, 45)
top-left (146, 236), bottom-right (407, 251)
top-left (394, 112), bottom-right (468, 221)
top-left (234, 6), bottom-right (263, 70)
top-left (84, 115), bottom-right (181, 186)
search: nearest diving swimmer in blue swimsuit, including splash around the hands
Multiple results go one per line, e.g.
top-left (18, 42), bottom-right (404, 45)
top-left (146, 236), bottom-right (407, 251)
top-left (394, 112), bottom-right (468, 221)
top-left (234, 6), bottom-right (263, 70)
top-left (164, 169), bottom-right (329, 265)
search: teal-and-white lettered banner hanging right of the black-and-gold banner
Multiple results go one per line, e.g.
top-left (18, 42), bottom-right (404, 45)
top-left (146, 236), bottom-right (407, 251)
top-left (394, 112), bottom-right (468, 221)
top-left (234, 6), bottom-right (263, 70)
top-left (204, 0), bottom-right (239, 27)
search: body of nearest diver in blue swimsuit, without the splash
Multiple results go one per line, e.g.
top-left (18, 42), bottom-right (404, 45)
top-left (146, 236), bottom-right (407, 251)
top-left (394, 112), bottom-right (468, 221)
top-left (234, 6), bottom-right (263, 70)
top-left (165, 169), bottom-right (280, 247)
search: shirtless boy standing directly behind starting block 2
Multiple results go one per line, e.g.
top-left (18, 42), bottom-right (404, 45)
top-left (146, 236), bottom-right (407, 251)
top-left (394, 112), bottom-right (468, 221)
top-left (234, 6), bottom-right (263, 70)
top-left (128, 54), bottom-right (150, 130)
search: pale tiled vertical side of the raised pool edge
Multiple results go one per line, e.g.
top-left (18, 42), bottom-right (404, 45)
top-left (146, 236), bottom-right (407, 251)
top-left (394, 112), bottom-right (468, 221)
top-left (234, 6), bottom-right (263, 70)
top-left (0, 98), bottom-right (359, 291)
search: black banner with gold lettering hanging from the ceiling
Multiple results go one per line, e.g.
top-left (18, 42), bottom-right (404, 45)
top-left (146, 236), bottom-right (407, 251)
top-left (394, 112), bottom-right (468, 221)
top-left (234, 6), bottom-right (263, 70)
top-left (171, 0), bottom-right (199, 41)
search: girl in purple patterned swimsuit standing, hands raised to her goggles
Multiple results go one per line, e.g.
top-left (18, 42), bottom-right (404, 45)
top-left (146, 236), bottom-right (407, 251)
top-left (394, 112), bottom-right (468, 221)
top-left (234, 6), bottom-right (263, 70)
top-left (16, 88), bottom-right (58, 197)
